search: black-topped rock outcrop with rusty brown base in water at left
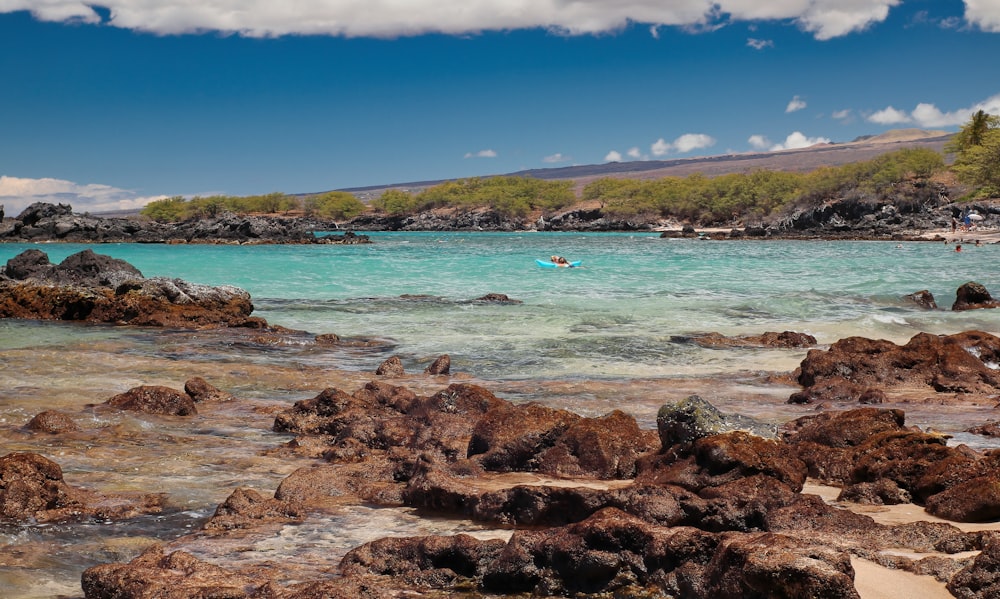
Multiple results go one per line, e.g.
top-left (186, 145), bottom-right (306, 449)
top-left (0, 249), bottom-right (267, 328)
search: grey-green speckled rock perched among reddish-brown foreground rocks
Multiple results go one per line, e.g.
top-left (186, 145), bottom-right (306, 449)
top-left (656, 395), bottom-right (776, 450)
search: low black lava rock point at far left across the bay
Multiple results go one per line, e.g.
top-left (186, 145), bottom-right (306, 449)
top-left (0, 202), bottom-right (371, 244)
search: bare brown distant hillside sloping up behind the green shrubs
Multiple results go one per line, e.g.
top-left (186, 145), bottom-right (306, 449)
top-left (338, 129), bottom-right (952, 200)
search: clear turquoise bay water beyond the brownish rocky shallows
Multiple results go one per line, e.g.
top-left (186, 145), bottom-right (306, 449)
top-left (0, 233), bottom-right (1000, 378)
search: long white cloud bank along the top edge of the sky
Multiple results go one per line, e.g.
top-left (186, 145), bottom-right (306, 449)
top-left (0, 0), bottom-right (916, 40)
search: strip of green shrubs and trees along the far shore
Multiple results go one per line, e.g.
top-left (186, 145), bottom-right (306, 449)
top-left (142, 111), bottom-right (1000, 224)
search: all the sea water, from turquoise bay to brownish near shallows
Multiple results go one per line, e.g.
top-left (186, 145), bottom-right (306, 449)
top-left (0, 233), bottom-right (1000, 599)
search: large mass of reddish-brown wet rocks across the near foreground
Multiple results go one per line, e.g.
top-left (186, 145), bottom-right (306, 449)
top-left (76, 381), bottom-right (1000, 599)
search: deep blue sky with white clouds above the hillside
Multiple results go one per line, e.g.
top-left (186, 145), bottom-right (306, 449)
top-left (0, 0), bottom-right (1000, 215)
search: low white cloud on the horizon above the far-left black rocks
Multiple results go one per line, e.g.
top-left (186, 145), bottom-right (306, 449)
top-left (0, 175), bottom-right (166, 216)
